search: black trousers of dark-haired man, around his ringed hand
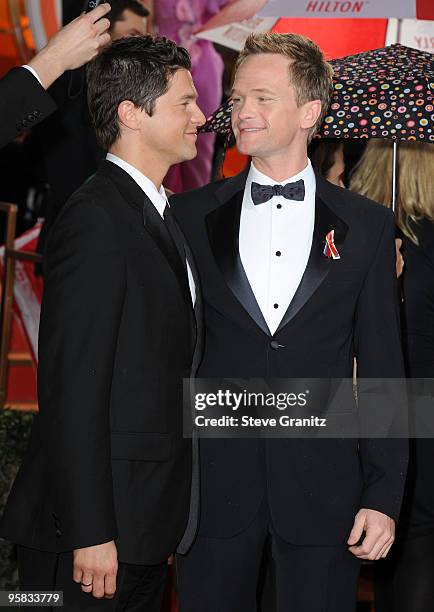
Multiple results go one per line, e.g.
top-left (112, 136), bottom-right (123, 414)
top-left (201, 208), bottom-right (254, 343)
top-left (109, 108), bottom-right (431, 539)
top-left (18, 546), bottom-right (167, 612)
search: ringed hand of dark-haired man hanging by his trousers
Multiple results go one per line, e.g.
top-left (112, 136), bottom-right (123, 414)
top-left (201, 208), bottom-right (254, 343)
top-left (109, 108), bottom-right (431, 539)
top-left (73, 540), bottom-right (118, 599)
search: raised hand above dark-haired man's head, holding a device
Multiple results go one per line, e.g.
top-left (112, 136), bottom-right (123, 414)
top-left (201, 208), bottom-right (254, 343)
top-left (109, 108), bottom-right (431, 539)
top-left (29, 3), bottom-right (111, 88)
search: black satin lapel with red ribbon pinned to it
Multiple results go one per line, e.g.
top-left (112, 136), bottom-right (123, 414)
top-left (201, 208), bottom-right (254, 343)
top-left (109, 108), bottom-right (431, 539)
top-left (276, 192), bottom-right (348, 333)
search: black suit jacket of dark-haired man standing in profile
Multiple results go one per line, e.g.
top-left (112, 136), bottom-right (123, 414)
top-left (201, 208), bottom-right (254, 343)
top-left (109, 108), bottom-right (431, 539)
top-left (0, 161), bottom-right (202, 564)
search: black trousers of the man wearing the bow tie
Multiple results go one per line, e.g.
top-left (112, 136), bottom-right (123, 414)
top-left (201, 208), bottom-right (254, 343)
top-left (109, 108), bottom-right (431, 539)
top-left (176, 502), bottom-right (360, 612)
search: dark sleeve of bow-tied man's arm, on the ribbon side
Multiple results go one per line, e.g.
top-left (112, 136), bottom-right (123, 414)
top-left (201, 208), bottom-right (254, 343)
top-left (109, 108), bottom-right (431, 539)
top-left (355, 211), bottom-right (408, 520)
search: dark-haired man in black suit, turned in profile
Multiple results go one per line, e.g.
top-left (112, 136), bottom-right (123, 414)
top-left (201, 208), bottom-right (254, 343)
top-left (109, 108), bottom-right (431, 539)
top-left (0, 36), bottom-right (205, 612)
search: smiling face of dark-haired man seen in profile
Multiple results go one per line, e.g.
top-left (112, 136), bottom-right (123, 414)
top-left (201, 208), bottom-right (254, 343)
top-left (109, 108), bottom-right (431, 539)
top-left (141, 69), bottom-right (205, 166)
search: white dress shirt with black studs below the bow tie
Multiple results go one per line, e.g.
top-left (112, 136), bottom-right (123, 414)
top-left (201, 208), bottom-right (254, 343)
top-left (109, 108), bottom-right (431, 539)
top-left (239, 160), bottom-right (316, 334)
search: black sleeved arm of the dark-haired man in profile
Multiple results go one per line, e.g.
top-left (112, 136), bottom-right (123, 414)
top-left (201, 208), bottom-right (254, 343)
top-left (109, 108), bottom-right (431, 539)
top-left (38, 196), bottom-right (126, 550)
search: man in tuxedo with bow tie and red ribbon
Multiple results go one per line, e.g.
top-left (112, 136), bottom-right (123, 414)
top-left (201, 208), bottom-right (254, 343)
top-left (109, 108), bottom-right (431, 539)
top-left (173, 33), bottom-right (407, 612)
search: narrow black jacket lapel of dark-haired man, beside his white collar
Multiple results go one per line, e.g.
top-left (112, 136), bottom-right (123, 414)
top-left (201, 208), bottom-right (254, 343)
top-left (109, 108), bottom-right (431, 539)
top-left (98, 160), bottom-right (190, 297)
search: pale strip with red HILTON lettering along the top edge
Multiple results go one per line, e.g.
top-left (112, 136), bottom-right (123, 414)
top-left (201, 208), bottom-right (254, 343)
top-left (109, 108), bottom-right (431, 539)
top-left (259, 0), bottom-right (434, 20)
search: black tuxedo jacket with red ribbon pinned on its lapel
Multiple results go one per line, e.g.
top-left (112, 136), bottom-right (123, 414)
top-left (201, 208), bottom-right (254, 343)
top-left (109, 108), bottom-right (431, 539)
top-left (171, 172), bottom-right (407, 545)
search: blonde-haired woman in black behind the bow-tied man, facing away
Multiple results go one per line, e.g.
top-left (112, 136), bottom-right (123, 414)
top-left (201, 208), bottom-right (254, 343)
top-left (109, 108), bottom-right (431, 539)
top-left (350, 140), bottom-right (434, 612)
